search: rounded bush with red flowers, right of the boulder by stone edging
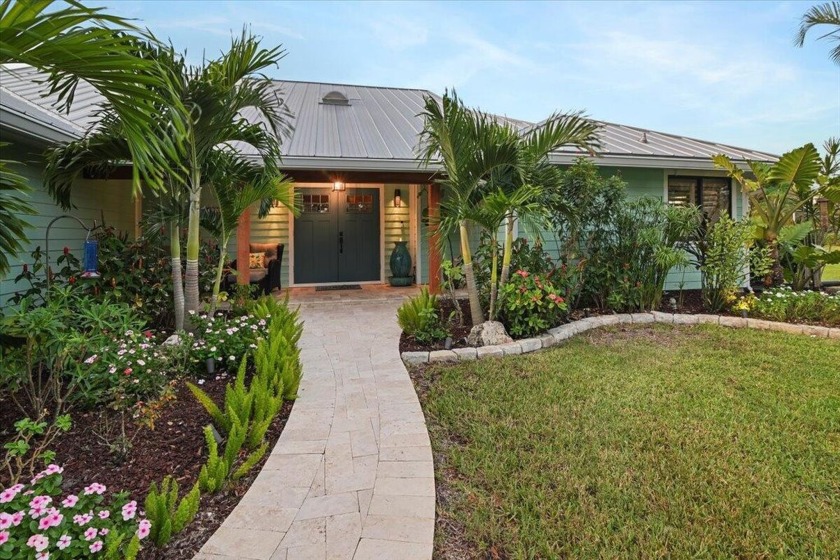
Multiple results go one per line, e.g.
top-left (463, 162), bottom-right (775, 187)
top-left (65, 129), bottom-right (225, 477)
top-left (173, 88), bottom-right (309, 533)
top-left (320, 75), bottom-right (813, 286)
top-left (499, 270), bottom-right (569, 338)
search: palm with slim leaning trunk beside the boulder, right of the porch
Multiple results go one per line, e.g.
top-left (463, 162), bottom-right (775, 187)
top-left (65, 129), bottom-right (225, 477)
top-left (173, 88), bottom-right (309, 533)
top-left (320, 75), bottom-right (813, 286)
top-left (420, 91), bottom-right (516, 325)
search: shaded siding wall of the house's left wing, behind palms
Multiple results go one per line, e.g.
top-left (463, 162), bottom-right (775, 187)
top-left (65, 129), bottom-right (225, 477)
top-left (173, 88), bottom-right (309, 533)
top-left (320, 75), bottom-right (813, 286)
top-left (0, 146), bottom-right (135, 306)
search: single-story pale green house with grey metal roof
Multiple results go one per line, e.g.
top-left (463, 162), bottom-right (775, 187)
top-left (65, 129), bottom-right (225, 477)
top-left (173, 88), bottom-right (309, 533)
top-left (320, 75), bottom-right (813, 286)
top-left (0, 66), bottom-right (776, 302)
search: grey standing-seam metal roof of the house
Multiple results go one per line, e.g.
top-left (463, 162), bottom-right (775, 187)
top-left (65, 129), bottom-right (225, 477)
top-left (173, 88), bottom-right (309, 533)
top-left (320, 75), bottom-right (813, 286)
top-left (0, 65), bottom-right (777, 171)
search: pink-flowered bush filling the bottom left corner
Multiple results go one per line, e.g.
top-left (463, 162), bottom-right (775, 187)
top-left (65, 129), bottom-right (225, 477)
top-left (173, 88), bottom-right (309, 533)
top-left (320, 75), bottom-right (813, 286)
top-left (0, 465), bottom-right (151, 560)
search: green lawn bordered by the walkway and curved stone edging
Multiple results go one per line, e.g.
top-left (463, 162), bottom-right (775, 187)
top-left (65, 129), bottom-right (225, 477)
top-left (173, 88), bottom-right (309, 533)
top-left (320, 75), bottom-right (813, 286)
top-left (418, 325), bottom-right (840, 558)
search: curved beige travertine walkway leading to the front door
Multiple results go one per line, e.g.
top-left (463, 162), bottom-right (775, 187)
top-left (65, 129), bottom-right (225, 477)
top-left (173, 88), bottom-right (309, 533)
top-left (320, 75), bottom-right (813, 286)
top-left (196, 288), bottom-right (435, 560)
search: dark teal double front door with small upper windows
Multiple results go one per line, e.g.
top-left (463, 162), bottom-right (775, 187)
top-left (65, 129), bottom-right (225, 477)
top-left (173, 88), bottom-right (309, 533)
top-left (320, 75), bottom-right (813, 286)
top-left (294, 188), bottom-right (380, 284)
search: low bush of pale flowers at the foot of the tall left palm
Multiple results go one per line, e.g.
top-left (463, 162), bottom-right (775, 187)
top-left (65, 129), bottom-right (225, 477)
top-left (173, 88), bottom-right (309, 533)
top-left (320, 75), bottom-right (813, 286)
top-left (190, 312), bottom-right (268, 368)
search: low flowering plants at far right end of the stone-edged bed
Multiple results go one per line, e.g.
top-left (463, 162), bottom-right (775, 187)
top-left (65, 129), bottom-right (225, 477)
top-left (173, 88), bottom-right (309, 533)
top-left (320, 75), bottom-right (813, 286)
top-left (736, 287), bottom-right (840, 326)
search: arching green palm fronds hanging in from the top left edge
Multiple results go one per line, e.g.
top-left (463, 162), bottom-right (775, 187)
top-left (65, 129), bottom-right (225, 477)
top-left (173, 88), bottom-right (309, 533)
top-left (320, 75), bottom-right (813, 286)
top-left (0, 0), bottom-right (179, 277)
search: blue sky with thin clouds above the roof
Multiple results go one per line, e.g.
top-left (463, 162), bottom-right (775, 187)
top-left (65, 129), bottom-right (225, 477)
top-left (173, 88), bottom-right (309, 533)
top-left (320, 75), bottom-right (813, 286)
top-left (113, 1), bottom-right (840, 153)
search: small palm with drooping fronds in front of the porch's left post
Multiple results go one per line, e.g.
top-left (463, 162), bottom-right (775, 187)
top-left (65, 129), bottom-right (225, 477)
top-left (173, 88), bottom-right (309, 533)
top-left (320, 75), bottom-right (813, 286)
top-left (202, 150), bottom-right (298, 311)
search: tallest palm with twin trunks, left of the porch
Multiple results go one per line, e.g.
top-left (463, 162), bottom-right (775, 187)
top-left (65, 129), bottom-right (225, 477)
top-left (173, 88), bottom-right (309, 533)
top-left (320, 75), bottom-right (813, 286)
top-left (45, 32), bottom-right (288, 327)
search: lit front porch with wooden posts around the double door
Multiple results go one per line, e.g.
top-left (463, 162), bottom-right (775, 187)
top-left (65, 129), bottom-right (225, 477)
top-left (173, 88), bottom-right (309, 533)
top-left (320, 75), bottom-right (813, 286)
top-left (236, 170), bottom-right (441, 296)
